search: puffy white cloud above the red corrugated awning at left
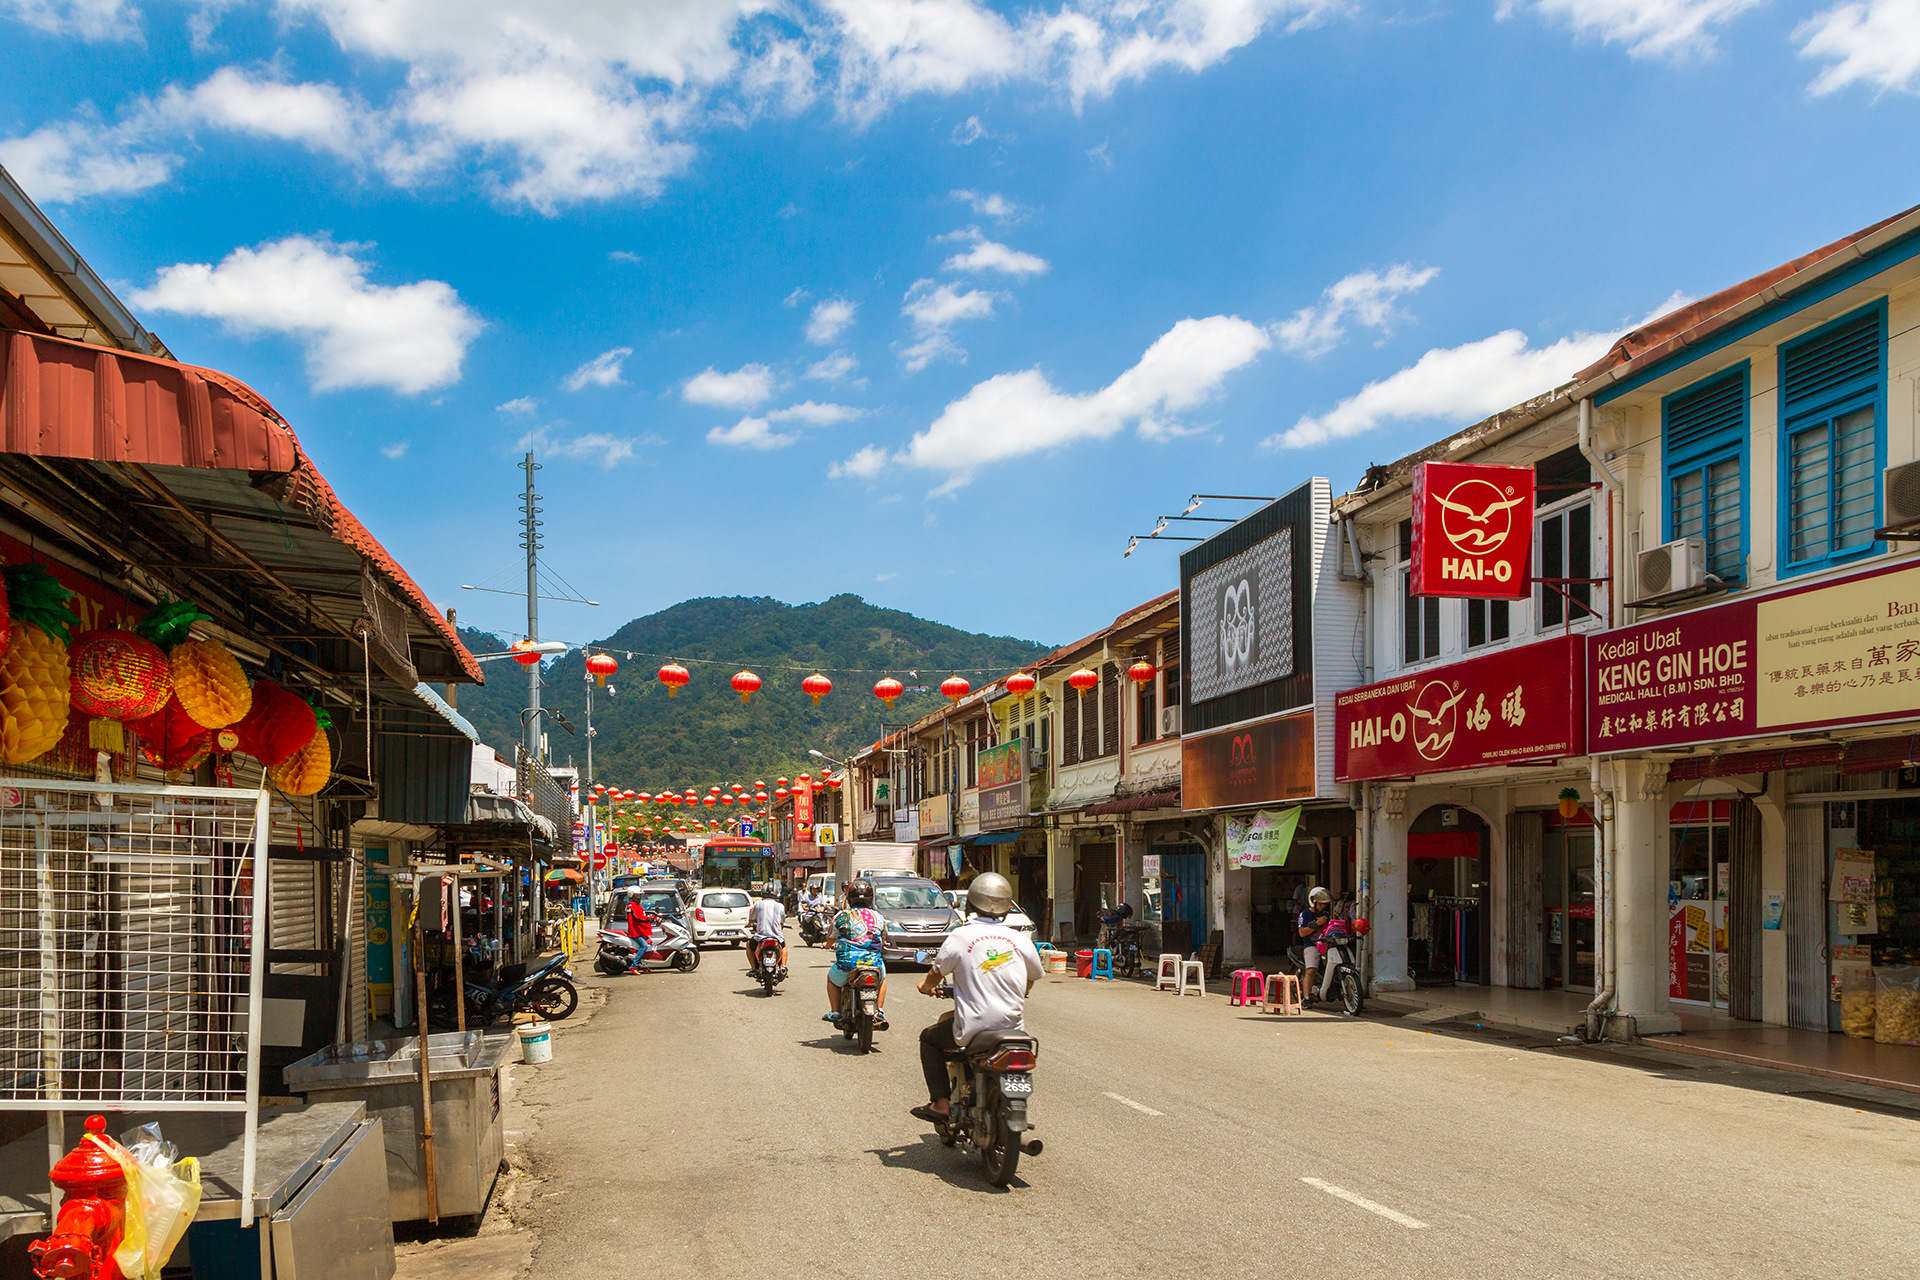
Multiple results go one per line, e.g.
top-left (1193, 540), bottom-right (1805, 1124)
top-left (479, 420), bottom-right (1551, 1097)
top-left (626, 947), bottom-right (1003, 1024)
top-left (132, 236), bottom-right (482, 393)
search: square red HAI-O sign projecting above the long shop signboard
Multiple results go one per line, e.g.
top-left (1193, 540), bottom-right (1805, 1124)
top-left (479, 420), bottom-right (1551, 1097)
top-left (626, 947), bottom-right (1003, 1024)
top-left (1413, 462), bottom-right (1534, 601)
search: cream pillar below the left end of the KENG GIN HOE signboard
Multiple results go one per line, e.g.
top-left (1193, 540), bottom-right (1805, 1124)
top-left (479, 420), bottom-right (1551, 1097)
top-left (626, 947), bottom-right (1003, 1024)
top-left (1613, 760), bottom-right (1680, 1036)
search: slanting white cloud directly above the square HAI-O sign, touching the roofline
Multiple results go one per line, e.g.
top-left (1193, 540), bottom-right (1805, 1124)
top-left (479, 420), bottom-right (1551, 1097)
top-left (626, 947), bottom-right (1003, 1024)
top-left (1260, 294), bottom-right (1692, 449)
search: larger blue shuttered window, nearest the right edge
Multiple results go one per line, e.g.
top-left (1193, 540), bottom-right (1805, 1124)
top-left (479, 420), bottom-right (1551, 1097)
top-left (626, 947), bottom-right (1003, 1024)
top-left (1780, 303), bottom-right (1885, 572)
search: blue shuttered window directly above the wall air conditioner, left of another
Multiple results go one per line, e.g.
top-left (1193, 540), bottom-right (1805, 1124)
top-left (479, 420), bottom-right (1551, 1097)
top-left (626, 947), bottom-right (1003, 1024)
top-left (1661, 365), bottom-right (1751, 581)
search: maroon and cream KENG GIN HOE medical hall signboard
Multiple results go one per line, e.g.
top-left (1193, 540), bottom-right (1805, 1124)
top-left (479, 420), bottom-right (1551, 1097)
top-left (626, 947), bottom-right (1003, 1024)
top-left (1588, 566), bottom-right (1920, 752)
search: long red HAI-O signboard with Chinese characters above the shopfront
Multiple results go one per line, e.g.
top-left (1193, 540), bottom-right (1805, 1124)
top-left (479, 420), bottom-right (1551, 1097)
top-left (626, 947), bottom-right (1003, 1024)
top-left (1332, 635), bottom-right (1586, 783)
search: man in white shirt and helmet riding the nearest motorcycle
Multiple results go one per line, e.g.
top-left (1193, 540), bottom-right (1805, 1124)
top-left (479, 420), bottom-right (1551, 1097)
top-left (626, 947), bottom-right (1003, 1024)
top-left (914, 871), bottom-right (1041, 1123)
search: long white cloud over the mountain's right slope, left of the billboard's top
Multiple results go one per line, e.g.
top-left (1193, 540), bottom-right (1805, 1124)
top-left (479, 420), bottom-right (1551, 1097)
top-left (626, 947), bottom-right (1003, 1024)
top-left (844, 315), bottom-right (1273, 493)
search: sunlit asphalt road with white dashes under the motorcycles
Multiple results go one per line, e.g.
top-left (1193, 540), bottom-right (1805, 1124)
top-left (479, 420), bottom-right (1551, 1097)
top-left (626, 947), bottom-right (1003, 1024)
top-left (516, 932), bottom-right (1920, 1280)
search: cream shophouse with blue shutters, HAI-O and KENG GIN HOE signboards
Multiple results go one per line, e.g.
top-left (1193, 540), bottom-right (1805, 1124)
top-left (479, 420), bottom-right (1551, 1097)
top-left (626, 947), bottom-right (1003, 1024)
top-left (1338, 197), bottom-right (1920, 1034)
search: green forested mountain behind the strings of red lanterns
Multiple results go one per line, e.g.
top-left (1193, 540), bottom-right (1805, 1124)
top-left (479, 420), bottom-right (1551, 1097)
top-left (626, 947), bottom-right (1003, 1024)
top-left (459, 595), bottom-right (1048, 791)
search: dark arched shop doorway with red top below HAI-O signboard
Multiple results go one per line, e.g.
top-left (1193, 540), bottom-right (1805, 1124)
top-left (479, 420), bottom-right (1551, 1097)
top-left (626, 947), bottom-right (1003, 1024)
top-left (1407, 804), bottom-right (1492, 986)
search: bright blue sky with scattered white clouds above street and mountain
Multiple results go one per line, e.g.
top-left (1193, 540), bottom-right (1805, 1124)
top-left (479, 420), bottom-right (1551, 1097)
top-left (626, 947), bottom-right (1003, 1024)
top-left (0, 0), bottom-right (1920, 641)
